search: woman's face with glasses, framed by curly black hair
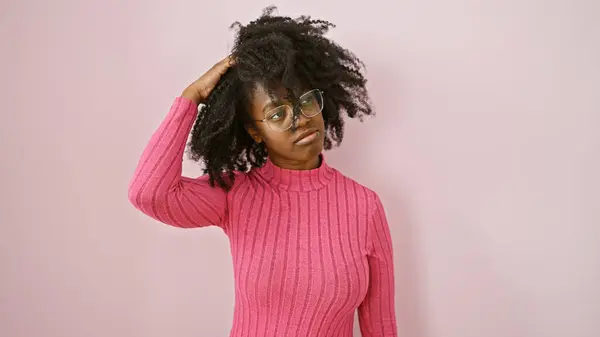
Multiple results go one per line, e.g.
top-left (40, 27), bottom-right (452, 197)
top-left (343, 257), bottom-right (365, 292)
top-left (248, 85), bottom-right (325, 165)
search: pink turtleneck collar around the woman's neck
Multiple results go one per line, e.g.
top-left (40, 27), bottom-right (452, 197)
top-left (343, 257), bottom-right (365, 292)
top-left (257, 154), bottom-right (336, 192)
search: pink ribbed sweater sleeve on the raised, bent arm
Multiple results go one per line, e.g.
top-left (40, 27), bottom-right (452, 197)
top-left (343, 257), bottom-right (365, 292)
top-left (129, 97), bottom-right (227, 228)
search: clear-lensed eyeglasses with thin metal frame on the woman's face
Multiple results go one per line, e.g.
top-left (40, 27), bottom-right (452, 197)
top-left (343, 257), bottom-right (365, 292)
top-left (255, 89), bottom-right (323, 132)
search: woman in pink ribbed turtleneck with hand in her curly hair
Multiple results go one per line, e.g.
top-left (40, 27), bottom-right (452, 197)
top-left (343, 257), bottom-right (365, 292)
top-left (129, 8), bottom-right (396, 337)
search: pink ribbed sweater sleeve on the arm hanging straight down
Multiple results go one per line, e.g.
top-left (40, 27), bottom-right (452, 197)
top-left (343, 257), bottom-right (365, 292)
top-left (358, 196), bottom-right (397, 337)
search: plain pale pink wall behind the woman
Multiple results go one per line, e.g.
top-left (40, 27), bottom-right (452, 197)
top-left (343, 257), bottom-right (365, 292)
top-left (0, 0), bottom-right (600, 337)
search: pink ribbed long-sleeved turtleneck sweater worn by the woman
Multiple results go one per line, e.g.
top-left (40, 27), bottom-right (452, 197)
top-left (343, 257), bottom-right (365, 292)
top-left (129, 97), bottom-right (397, 337)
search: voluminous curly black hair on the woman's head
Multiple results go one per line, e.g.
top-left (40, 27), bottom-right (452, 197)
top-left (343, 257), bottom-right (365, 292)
top-left (189, 6), bottom-right (373, 190)
